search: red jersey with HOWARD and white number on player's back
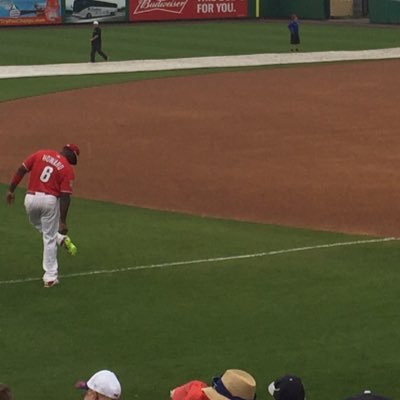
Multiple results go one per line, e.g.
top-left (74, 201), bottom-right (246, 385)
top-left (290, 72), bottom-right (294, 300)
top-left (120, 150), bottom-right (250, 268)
top-left (23, 150), bottom-right (75, 197)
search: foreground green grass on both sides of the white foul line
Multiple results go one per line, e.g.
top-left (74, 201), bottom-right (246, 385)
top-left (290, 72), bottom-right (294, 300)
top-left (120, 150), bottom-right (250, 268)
top-left (0, 186), bottom-right (400, 400)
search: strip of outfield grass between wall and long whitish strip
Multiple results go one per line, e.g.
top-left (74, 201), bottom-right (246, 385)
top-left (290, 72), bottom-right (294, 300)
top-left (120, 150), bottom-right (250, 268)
top-left (0, 20), bottom-right (399, 65)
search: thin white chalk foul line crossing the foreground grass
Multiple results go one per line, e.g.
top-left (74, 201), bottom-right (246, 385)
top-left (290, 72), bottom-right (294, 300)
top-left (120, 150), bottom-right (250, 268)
top-left (0, 237), bottom-right (399, 285)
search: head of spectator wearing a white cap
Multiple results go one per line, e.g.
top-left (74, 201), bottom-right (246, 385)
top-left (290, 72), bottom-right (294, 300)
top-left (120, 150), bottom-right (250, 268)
top-left (75, 370), bottom-right (121, 400)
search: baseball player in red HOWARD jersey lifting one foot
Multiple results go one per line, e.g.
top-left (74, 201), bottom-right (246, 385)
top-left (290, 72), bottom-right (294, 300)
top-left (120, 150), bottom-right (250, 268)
top-left (6, 144), bottom-right (80, 288)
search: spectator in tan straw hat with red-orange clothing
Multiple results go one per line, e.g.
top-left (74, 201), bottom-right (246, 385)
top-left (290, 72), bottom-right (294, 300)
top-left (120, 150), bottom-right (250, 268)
top-left (170, 369), bottom-right (256, 400)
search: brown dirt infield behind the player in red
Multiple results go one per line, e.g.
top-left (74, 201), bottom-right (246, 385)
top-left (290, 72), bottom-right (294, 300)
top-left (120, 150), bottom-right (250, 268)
top-left (0, 60), bottom-right (400, 236)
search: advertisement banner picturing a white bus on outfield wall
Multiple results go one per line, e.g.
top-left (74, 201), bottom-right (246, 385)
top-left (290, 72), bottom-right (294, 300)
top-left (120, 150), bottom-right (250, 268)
top-left (64, 0), bottom-right (127, 24)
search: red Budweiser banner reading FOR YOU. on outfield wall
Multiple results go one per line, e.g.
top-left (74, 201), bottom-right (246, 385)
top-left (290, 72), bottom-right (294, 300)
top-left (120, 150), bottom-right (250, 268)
top-left (129, 0), bottom-right (248, 21)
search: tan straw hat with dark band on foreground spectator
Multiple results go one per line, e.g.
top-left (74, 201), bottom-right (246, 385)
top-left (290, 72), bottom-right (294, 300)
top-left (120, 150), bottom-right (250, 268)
top-left (202, 369), bottom-right (256, 400)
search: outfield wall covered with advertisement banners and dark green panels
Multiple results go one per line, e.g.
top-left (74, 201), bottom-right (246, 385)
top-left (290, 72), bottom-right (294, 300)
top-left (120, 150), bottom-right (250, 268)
top-left (0, 0), bottom-right (400, 26)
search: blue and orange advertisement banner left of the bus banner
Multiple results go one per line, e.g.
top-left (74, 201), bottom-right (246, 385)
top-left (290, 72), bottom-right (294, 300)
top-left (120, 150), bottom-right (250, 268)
top-left (0, 0), bottom-right (61, 26)
